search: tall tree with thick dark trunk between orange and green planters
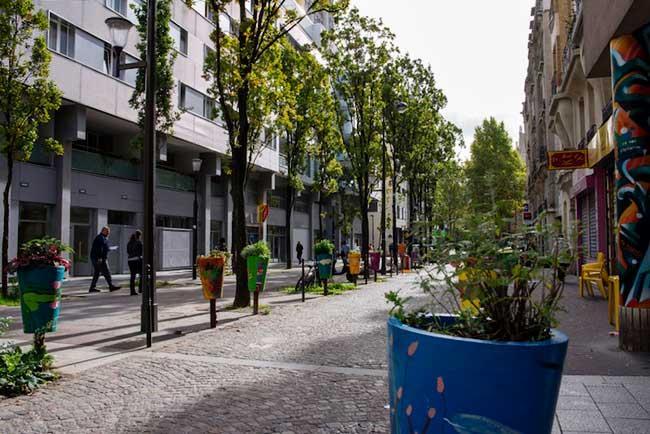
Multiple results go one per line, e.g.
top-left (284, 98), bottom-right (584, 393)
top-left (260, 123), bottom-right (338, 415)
top-left (199, 0), bottom-right (346, 307)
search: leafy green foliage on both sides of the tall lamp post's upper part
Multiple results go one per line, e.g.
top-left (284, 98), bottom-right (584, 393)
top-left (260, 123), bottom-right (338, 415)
top-left (129, 0), bottom-right (180, 144)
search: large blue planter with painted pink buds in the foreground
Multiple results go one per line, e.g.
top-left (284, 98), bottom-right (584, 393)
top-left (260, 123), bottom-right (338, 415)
top-left (388, 317), bottom-right (568, 434)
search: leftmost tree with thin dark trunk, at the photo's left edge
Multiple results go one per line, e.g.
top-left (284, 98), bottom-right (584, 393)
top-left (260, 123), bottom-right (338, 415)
top-left (0, 0), bottom-right (63, 296)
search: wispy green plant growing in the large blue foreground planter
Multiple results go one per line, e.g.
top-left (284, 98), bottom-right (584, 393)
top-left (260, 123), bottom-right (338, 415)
top-left (386, 219), bottom-right (574, 342)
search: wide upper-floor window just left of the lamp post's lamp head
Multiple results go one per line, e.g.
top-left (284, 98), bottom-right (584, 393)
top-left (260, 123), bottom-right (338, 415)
top-left (48, 15), bottom-right (111, 74)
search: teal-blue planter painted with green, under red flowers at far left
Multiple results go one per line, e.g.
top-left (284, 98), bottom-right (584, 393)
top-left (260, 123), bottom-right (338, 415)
top-left (18, 267), bottom-right (65, 333)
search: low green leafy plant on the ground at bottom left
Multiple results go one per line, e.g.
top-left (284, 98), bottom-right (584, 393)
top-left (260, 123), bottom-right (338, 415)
top-left (0, 345), bottom-right (57, 396)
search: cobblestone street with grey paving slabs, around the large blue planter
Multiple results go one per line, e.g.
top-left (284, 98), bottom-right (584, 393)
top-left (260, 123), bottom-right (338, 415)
top-left (0, 275), bottom-right (650, 434)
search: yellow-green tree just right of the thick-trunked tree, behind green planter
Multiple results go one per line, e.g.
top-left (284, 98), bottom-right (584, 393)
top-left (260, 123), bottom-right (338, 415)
top-left (276, 41), bottom-right (340, 269)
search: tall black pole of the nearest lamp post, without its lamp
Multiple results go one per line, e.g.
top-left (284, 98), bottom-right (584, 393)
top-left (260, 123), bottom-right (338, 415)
top-left (142, 0), bottom-right (158, 347)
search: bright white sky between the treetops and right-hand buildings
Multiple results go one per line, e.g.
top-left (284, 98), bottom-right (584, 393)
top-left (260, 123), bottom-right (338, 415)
top-left (352, 0), bottom-right (535, 159)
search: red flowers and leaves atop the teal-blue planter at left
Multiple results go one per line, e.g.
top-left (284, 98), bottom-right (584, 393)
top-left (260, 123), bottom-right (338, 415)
top-left (9, 238), bottom-right (73, 273)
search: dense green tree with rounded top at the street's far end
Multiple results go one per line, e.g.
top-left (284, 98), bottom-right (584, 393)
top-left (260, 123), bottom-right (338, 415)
top-left (466, 117), bottom-right (526, 219)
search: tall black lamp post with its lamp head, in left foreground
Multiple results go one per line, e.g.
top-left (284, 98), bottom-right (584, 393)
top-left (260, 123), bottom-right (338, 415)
top-left (106, 0), bottom-right (158, 347)
